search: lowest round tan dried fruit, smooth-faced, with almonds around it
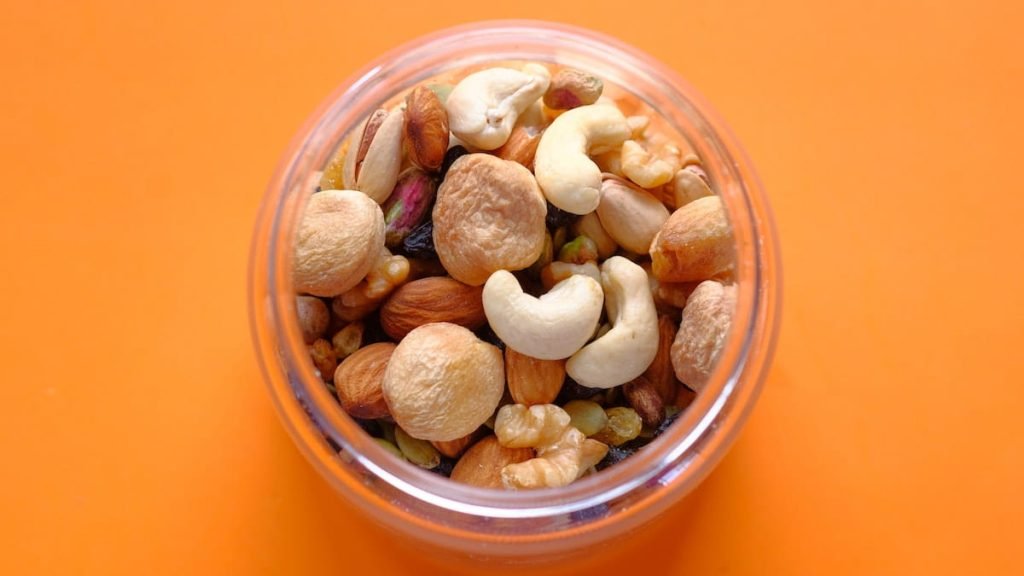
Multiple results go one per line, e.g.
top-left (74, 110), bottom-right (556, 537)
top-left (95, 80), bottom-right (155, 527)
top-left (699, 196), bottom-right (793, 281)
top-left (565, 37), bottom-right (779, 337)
top-left (382, 322), bottom-right (505, 441)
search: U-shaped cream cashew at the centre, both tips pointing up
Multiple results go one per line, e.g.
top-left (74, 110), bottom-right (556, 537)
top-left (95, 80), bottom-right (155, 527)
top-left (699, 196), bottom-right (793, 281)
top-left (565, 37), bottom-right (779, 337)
top-left (483, 270), bottom-right (602, 358)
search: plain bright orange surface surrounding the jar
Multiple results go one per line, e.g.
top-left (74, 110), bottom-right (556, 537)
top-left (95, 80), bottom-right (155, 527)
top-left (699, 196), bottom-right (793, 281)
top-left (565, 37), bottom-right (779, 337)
top-left (0, 0), bottom-right (1024, 574)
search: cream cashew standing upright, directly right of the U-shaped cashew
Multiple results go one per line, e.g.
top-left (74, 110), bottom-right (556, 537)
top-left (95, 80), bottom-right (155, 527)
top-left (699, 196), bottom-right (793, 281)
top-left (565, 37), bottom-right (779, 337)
top-left (565, 256), bottom-right (658, 388)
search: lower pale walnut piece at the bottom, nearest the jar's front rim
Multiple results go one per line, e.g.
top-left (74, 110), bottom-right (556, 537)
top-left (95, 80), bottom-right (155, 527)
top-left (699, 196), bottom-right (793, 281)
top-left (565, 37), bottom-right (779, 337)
top-left (502, 426), bottom-right (587, 489)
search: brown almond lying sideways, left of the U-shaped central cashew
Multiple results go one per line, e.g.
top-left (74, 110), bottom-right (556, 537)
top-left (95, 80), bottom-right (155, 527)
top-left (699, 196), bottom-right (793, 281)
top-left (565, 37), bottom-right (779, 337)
top-left (380, 277), bottom-right (486, 340)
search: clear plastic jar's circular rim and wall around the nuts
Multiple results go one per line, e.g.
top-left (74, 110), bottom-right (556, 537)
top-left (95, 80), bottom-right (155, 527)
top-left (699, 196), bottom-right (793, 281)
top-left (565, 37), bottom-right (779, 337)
top-left (250, 22), bottom-right (781, 562)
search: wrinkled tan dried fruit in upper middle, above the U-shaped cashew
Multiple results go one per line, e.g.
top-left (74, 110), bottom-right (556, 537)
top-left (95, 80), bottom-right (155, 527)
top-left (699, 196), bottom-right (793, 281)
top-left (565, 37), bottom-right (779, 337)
top-left (433, 154), bottom-right (548, 286)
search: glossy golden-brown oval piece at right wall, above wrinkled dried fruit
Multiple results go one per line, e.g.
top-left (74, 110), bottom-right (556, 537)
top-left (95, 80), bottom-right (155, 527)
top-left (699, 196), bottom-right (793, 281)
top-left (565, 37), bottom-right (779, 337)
top-left (650, 196), bottom-right (734, 282)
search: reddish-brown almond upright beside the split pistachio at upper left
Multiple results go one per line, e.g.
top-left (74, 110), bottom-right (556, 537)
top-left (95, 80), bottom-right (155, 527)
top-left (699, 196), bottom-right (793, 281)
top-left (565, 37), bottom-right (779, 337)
top-left (406, 86), bottom-right (449, 171)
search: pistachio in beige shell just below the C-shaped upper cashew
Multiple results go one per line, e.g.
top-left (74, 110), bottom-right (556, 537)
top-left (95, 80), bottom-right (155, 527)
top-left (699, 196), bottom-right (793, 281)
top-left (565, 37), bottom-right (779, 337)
top-left (597, 178), bottom-right (669, 254)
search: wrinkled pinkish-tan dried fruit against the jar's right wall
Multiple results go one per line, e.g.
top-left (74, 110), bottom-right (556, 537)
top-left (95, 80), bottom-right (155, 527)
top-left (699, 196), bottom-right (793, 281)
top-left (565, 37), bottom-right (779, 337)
top-left (672, 280), bottom-right (736, 392)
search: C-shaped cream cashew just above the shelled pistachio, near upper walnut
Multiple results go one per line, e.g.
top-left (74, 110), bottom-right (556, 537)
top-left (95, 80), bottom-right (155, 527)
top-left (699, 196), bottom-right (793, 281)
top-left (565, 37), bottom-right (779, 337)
top-left (534, 105), bottom-right (630, 215)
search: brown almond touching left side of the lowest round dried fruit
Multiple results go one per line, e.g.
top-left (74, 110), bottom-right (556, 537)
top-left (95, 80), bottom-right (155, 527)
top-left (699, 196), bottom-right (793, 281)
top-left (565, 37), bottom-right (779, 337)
top-left (334, 342), bottom-right (395, 419)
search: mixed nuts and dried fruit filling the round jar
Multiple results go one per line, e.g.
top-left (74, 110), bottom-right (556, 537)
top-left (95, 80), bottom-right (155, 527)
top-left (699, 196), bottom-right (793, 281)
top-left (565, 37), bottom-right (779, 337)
top-left (293, 63), bottom-right (736, 489)
